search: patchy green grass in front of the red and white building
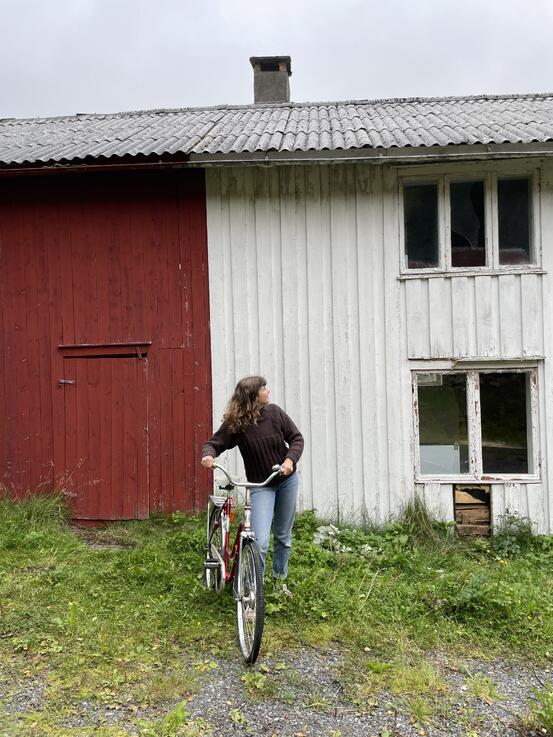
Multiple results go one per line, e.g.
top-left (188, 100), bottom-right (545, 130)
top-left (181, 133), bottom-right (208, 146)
top-left (0, 494), bottom-right (553, 737)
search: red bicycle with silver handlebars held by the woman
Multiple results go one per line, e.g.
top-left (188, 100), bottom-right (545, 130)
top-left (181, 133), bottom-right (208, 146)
top-left (204, 463), bottom-right (280, 663)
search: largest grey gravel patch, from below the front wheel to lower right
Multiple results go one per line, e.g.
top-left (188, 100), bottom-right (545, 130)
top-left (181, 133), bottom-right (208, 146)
top-left (188, 649), bottom-right (552, 737)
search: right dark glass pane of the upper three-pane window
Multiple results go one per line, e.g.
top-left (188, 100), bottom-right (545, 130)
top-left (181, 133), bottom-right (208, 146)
top-left (497, 178), bottom-right (530, 264)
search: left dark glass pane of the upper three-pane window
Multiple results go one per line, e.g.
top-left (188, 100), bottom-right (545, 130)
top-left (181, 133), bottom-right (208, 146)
top-left (403, 184), bottom-right (439, 269)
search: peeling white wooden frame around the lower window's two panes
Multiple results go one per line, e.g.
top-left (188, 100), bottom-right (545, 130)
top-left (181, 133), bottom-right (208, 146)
top-left (411, 366), bottom-right (541, 483)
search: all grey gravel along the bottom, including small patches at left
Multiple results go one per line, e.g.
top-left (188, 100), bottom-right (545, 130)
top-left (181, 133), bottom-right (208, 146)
top-left (0, 648), bottom-right (553, 737)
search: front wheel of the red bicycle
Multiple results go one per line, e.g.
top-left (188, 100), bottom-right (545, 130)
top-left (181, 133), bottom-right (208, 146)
top-left (236, 538), bottom-right (265, 663)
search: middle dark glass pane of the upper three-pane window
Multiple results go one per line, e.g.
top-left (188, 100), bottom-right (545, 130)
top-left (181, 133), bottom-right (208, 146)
top-left (449, 182), bottom-right (486, 266)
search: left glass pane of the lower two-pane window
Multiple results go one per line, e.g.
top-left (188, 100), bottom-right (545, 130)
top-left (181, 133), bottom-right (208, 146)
top-left (418, 374), bottom-right (469, 474)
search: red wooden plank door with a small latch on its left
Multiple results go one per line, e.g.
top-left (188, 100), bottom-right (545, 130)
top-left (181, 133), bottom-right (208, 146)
top-left (59, 353), bottom-right (149, 520)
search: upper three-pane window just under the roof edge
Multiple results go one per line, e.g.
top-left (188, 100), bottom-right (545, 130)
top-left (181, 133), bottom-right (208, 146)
top-left (402, 171), bottom-right (537, 272)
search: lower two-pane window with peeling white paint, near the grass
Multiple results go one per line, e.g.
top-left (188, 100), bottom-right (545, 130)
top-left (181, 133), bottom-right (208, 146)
top-left (413, 368), bottom-right (537, 479)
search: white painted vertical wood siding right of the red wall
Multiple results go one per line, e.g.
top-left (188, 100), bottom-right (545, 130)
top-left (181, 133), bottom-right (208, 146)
top-left (206, 164), bottom-right (553, 530)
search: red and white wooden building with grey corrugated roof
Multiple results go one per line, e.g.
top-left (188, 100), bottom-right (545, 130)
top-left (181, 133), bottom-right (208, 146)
top-left (0, 57), bottom-right (553, 531)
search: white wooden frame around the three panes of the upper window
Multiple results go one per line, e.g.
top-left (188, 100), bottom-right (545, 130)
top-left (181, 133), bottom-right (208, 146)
top-left (398, 162), bottom-right (541, 277)
